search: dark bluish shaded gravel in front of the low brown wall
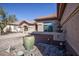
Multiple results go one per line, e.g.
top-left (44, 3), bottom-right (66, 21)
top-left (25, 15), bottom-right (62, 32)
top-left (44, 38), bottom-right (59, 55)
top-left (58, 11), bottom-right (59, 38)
top-left (37, 43), bottom-right (64, 56)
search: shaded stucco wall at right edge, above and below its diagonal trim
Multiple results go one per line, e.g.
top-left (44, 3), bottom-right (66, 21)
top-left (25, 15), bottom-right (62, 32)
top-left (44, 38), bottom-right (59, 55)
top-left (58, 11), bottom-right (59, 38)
top-left (61, 3), bottom-right (79, 55)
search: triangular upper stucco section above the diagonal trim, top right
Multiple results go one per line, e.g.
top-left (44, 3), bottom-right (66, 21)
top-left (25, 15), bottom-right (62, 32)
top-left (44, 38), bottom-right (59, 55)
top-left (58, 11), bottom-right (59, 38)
top-left (61, 3), bottom-right (79, 24)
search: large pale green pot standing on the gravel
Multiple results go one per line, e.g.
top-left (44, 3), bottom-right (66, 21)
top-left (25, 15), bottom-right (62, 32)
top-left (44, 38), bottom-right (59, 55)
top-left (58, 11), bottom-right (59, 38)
top-left (23, 36), bottom-right (35, 50)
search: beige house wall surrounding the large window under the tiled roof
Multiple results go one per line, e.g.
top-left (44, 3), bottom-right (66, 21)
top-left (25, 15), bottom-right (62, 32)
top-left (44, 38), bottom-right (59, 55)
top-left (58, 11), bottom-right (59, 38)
top-left (37, 20), bottom-right (58, 32)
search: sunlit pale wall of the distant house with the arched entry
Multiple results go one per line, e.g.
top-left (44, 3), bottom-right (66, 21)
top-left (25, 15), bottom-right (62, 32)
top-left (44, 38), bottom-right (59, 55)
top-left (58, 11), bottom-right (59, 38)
top-left (4, 23), bottom-right (36, 33)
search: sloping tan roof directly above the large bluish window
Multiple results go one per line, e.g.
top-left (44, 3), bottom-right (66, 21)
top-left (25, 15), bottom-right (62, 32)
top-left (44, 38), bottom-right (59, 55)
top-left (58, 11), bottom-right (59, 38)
top-left (35, 13), bottom-right (57, 21)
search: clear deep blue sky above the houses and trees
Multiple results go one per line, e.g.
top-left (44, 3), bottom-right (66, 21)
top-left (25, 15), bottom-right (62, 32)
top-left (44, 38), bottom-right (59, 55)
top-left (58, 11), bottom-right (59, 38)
top-left (0, 3), bottom-right (57, 20)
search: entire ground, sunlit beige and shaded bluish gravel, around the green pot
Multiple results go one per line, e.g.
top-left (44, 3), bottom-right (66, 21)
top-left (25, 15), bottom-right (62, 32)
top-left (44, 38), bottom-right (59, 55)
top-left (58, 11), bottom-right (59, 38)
top-left (0, 33), bottom-right (64, 56)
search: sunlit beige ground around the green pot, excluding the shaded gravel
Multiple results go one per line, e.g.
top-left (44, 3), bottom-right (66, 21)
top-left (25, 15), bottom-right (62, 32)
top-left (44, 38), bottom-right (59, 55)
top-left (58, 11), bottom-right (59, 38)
top-left (0, 33), bottom-right (42, 56)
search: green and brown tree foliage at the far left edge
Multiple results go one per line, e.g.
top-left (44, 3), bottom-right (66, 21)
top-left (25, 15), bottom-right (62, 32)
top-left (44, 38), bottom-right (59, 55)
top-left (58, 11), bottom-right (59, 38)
top-left (0, 7), bottom-right (17, 34)
